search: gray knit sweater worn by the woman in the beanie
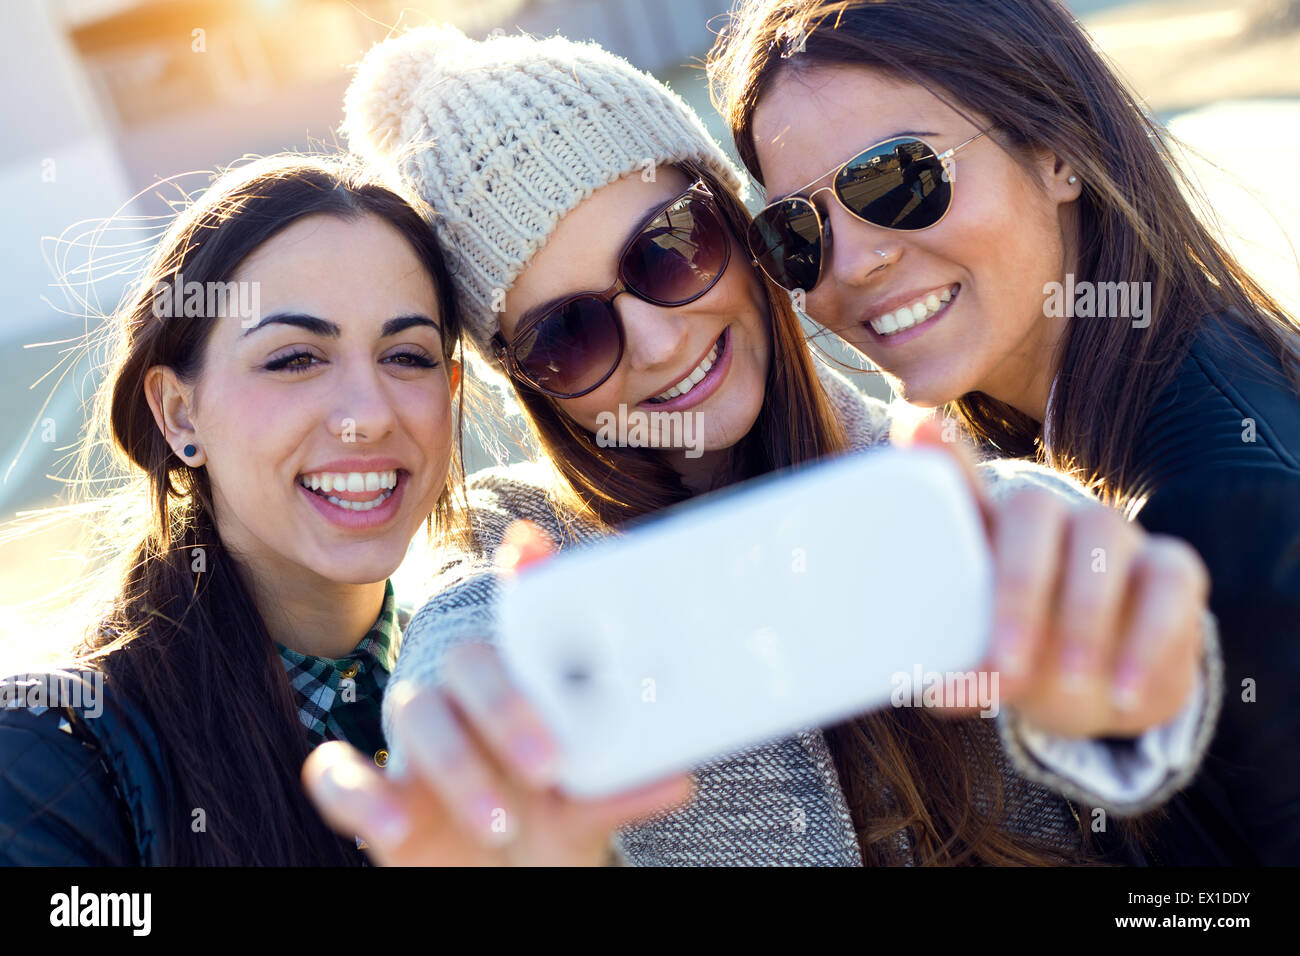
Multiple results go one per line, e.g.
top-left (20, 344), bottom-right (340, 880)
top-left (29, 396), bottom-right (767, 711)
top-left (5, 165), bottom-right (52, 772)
top-left (384, 363), bottom-right (1222, 866)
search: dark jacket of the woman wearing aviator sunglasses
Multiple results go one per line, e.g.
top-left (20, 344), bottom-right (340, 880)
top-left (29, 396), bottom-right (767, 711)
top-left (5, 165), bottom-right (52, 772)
top-left (1115, 316), bottom-right (1300, 866)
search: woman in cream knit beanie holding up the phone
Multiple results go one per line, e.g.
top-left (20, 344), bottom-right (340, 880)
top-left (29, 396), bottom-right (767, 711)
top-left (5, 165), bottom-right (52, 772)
top-left (304, 27), bottom-right (1218, 865)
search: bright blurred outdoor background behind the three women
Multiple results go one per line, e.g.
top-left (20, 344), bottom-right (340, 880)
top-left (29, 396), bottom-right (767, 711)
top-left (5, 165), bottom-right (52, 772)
top-left (0, 0), bottom-right (1300, 630)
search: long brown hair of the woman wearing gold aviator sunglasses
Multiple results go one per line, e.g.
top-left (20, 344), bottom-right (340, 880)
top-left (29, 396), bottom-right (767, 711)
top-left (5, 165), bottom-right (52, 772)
top-left (709, 0), bottom-right (1300, 505)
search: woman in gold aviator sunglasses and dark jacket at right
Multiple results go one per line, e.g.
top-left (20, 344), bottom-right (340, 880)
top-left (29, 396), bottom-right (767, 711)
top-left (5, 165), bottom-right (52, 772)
top-left (710, 0), bottom-right (1300, 864)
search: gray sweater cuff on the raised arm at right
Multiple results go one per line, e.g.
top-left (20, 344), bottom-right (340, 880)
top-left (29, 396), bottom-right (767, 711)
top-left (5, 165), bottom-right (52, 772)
top-left (979, 460), bottom-right (1223, 816)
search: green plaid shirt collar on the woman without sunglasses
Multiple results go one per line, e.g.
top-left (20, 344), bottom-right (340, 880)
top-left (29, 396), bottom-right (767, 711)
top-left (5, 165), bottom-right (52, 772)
top-left (276, 581), bottom-right (407, 767)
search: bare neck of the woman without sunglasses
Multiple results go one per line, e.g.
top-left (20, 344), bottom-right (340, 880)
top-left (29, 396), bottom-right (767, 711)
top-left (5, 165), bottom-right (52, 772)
top-left (242, 558), bottom-right (386, 659)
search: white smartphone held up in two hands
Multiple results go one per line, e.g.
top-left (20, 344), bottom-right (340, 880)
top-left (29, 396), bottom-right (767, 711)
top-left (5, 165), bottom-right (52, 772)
top-left (499, 449), bottom-right (993, 797)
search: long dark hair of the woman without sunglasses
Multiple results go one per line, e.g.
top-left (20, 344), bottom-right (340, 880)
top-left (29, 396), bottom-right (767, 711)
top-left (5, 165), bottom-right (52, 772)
top-left (29, 155), bottom-right (464, 866)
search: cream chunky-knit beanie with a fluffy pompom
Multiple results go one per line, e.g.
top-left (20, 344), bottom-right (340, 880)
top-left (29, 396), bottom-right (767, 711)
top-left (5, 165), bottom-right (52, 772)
top-left (343, 26), bottom-right (745, 371)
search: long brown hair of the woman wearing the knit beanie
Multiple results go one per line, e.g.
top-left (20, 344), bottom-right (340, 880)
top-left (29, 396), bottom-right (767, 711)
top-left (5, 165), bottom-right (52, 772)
top-left (501, 163), bottom-right (1102, 865)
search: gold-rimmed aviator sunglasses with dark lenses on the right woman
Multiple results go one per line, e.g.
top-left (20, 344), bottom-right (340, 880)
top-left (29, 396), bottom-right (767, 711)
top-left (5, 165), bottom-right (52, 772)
top-left (746, 130), bottom-right (988, 291)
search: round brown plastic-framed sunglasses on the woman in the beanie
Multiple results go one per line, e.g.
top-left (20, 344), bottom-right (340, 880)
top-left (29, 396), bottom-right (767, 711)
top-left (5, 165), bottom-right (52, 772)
top-left (491, 179), bottom-right (731, 398)
